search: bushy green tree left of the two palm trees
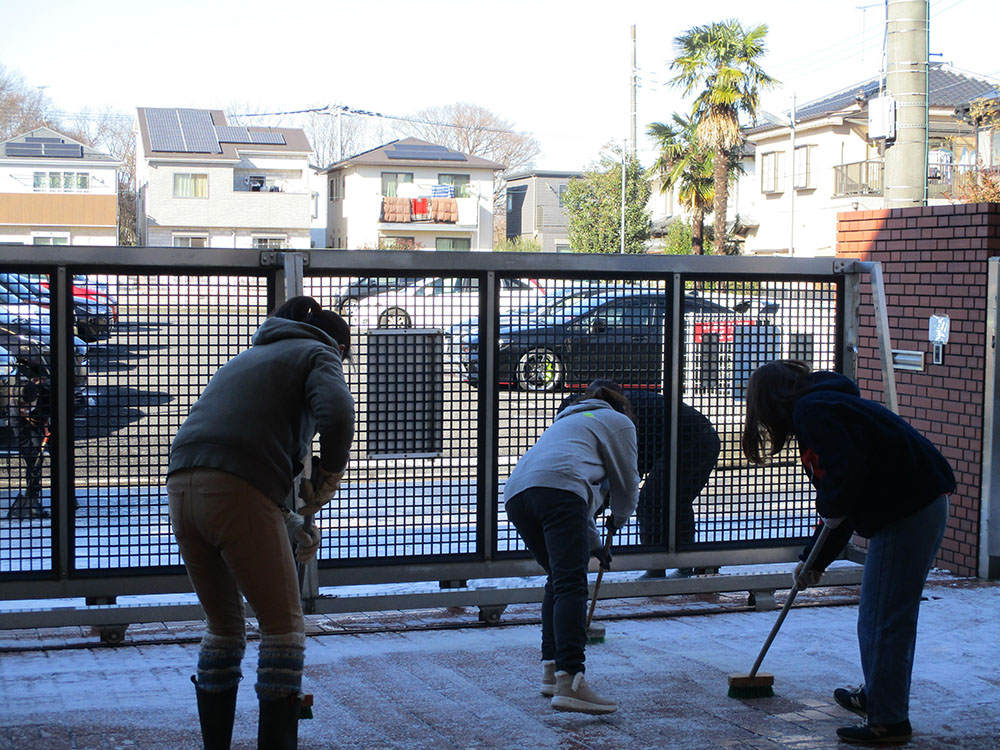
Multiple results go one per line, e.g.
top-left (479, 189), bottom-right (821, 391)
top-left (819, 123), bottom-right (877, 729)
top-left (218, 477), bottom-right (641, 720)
top-left (564, 154), bottom-right (651, 254)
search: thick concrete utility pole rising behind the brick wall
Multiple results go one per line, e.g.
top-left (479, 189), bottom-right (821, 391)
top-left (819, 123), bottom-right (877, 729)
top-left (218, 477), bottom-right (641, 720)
top-left (885, 0), bottom-right (930, 208)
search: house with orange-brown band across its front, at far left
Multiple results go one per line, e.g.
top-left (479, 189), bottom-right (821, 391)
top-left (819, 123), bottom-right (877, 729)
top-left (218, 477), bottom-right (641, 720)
top-left (0, 128), bottom-right (120, 245)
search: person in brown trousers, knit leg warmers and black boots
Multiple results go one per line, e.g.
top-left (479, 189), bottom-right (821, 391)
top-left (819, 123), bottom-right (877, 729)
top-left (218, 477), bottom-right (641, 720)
top-left (167, 297), bottom-right (354, 750)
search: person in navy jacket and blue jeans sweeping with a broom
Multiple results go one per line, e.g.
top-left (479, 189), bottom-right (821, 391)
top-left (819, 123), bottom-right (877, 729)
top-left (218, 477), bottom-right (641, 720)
top-left (742, 360), bottom-right (955, 744)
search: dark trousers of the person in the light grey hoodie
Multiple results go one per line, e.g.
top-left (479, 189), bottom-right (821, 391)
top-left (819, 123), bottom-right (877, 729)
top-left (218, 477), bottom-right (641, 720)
top-left (507, 487), bottom-right (591, 674)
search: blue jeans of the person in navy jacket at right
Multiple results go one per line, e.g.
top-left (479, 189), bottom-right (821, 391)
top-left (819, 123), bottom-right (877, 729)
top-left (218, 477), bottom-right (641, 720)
top-left (858, 495), bottom-right (948, 724)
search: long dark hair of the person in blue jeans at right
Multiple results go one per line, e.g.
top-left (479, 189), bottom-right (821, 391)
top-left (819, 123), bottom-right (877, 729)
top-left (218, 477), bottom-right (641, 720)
top-left (740, 359), bottom-right (812, 464)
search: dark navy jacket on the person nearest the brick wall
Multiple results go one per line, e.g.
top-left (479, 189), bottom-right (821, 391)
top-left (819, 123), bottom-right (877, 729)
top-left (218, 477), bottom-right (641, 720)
top-left (792, 372), bottom-right (955, 570)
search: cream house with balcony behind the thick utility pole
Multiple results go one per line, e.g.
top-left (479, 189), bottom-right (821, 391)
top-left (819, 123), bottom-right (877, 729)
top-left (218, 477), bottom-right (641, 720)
top-left (731, 63), bottom-right (1000, 256)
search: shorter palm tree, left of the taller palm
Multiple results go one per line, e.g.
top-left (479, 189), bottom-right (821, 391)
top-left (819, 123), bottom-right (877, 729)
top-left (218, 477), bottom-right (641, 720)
top-left (646, 113), bottom-right (715, 255)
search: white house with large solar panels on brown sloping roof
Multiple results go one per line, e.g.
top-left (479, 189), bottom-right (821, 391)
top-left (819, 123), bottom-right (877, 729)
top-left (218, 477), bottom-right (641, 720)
top-left (136, 107), bottom-right (319, 249)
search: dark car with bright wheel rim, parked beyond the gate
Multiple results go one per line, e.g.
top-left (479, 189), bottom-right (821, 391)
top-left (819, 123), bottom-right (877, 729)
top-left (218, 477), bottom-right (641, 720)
top-left (459, 289), bottom-right (753, 391)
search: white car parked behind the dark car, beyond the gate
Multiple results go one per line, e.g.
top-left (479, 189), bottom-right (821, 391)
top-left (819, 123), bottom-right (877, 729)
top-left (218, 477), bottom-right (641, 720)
top-left (351, 277), bottom-right (544, 330)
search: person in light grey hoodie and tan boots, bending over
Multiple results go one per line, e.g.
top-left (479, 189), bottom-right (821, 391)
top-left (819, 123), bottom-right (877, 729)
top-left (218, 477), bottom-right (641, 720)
top-left (504, 380), bottom-right (639, 714)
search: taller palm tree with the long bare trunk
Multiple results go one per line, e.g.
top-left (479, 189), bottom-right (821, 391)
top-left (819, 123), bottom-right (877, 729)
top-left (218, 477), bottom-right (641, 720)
top-left (670, 19), bottom-right (776, 254)
